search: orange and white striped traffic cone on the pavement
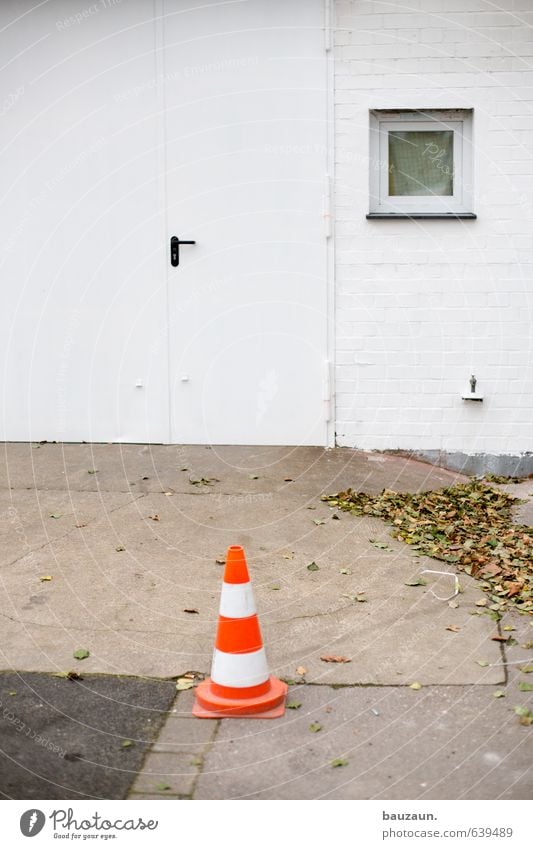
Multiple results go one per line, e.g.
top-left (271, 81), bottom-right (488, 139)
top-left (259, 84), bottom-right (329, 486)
top-left (192, 545), bottom-right (288, 719)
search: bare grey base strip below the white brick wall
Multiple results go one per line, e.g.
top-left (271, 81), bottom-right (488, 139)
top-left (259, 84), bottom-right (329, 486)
top-left (384, 450), bottom-right (533, 478)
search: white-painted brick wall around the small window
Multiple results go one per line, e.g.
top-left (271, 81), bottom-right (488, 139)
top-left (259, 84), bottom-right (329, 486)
top-left (334, 0), bottom-right (533, 454)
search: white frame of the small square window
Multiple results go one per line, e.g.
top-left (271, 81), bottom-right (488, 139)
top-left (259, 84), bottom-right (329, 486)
top-left (369, 109), bottom-right (475, 218)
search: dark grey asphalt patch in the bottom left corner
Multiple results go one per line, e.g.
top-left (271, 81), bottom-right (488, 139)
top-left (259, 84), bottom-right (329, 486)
top-left (0, 673), bottom-right (175, 799)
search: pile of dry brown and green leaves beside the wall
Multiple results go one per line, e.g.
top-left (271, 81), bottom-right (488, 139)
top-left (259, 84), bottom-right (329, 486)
top-left (322, 480), bottom-right (533, 614)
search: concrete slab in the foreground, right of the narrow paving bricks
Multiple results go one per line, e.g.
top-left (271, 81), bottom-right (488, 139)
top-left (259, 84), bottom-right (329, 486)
top-left (185, 685), bottom-right (533, 799)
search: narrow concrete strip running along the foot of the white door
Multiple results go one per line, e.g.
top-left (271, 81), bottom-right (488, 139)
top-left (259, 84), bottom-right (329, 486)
top-left (0, 443), bottom-right (465, 495)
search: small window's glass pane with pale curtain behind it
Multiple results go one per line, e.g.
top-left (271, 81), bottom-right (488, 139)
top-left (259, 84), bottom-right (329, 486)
top-left (389, 130), bottom-right (453, 195)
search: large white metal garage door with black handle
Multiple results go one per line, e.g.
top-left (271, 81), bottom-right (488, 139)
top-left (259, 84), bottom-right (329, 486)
top-left (0, 0), bottom-right (328, 445)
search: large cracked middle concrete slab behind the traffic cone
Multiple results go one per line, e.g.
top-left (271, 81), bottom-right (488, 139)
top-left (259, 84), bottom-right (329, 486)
top-left (1, 476), bottom-right (502, 684)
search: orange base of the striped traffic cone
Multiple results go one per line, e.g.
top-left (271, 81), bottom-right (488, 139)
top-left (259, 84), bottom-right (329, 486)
top-left (192, 675), bottom-right (289, 719)
